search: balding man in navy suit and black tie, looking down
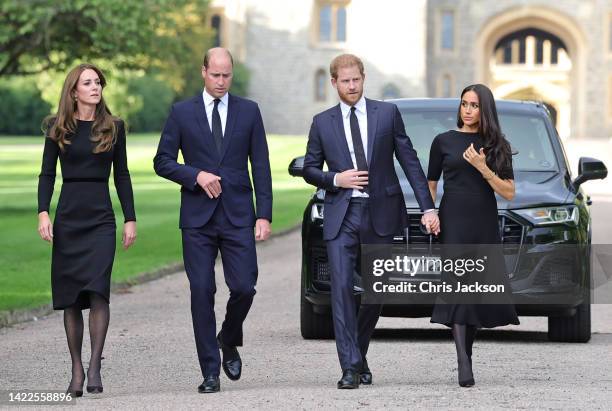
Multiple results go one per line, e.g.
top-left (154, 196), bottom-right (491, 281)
top-left (154, 48), bottom-right (272, 393)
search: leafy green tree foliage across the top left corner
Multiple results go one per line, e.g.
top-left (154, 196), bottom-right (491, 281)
top-left (0, 0), bottom-right (212, 85)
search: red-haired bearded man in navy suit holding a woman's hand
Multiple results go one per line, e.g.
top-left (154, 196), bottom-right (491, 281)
top-left (303, 54), bottom-right (439, 388)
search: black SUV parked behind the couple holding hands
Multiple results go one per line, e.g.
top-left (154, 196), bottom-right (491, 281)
top-left (289, 99), bottom-right (607, 342)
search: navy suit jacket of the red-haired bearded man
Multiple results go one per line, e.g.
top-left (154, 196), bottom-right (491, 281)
top-left (303, 99), bottom-right (435, 240)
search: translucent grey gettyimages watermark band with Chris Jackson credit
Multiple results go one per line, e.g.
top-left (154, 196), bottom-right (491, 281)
top-left (359, 243), bottom-right (612, 306)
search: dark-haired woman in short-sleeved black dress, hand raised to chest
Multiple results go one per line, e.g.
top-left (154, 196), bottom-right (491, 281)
top-left (427, 84), bottom-right (519, 387)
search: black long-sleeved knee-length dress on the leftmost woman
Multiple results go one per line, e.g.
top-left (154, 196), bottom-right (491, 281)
top-left (38, 120), bottom-right (136, 310)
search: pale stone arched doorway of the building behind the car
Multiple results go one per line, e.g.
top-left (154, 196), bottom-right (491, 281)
top-left (475, 6), bottom-right (585, 138)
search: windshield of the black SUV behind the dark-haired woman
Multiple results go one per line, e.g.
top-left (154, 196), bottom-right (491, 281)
top-left (396, 109), bottom-right (558, 173)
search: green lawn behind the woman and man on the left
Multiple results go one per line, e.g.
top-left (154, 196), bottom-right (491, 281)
top-left (0, 134), bottom-right (312, 311)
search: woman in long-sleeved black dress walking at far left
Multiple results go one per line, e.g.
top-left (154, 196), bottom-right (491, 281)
top-left (38, 64), bottom-right (136, 397)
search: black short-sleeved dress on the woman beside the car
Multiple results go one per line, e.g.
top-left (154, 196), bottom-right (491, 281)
top-left (427, 130), bottom-right (519, 328)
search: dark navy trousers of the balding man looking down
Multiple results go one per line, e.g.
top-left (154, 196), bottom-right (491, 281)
top-left (182, 202), bottom-right (257, 376)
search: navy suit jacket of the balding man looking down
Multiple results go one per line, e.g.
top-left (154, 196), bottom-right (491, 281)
top-left (153, 94), bottom-right (272, 228)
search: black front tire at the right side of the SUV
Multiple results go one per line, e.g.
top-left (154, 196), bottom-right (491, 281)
top-left (548, 300), bottom-right (591, 343)
